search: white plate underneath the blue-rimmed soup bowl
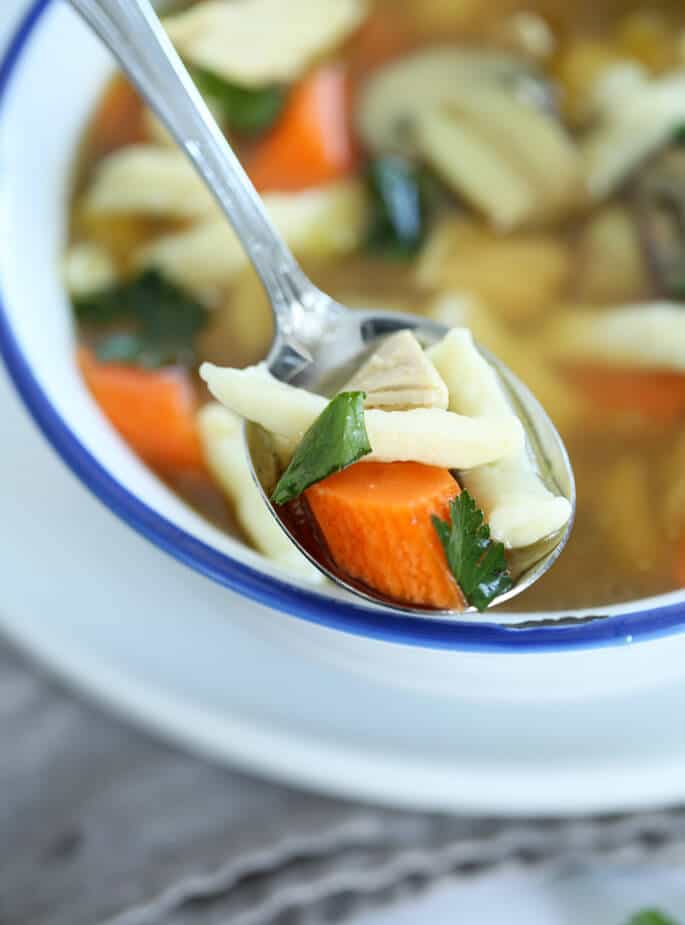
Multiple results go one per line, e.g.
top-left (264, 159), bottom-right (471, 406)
top-left (0, 360), bottom-right (685, 813)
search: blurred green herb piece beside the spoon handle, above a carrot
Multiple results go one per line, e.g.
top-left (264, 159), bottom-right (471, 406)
top-left (192, 68), bottom-right (285, 135)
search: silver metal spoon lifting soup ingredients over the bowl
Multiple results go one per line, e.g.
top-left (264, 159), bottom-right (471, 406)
top-left (69, 0), bottom-right (575, 616)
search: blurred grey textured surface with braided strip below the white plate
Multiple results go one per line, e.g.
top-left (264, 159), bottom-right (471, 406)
top-left (0, 644), bottom-right (685, 925)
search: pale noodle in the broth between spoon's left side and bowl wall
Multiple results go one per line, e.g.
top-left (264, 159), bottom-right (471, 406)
top-left (197, 402), bottom-right (323, 582)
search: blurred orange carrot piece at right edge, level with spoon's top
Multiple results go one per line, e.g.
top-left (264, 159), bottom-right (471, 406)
top-left (568, 366), bottom-right (685, 424)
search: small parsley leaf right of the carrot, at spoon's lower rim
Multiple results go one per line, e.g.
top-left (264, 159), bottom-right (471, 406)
top-left (432, 491), bottom-right (513, 611)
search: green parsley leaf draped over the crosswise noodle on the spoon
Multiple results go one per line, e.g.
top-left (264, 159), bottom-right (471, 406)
top-left (271, 392), bottom-right (371, 504)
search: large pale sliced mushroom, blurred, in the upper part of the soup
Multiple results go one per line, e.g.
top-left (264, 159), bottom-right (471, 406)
top-left (358, 46), bottom-right (582, 229)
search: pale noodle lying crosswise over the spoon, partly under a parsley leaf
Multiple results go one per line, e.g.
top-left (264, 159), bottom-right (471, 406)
top-left (200, 363), bottom-right (524, 469)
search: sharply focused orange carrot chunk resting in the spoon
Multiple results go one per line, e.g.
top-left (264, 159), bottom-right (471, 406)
top-left (306, 462), bottom-right (464, 610)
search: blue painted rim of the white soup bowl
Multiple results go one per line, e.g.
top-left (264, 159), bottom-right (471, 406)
top-left (0, 0), bottom-right (685, 653)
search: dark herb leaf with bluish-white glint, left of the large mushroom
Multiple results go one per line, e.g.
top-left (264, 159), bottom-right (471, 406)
top-left (367, 154), bottom-right (440, 258)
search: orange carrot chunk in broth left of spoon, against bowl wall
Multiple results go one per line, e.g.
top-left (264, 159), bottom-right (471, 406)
top-left (78, 347), bottom-right (204, 472)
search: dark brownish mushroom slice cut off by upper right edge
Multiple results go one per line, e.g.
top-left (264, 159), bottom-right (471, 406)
top-left (635, 144), bottom-right (685, 300)
